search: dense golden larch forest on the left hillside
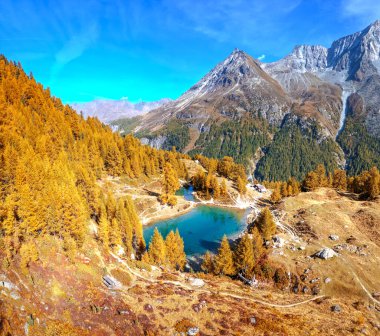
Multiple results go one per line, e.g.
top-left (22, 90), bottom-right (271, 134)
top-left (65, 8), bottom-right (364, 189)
top-left (0, 57), bottom-right (186, 266)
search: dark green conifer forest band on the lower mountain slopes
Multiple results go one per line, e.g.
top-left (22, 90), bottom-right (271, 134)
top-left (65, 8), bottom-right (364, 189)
top-left (108, 112), bottom-right (380, 181)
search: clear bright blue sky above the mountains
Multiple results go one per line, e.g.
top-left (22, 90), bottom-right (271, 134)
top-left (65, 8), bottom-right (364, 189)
top-left (0, 0), bottom-right (380, 102)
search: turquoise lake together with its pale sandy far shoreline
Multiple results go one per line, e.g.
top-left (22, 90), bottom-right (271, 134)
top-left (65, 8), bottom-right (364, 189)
top-left (144, 188), bottom-right (255, 255)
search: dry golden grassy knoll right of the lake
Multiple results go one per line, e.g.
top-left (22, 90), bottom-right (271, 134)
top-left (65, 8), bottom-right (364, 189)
top-left (282, 188), bottom-right (380, 305)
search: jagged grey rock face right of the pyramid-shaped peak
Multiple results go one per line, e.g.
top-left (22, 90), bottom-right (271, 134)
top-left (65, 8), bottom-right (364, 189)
top-left (263, 21), bottom-right (380, 137)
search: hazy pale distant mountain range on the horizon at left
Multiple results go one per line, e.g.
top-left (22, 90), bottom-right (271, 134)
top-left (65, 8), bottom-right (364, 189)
top-left (70, 99), bottom-right (170, 123)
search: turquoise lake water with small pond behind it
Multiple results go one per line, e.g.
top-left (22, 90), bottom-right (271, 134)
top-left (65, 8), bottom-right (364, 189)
top-left (144, 189), bottom-right (245, 256)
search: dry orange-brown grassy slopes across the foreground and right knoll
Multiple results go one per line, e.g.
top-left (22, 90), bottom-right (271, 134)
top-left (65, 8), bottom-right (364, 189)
top-left (0, 189), bottom-right (380, 335)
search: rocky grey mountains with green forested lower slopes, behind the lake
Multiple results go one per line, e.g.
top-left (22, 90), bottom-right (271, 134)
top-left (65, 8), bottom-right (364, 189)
top-left (99, 21), bottom-right (380, 179)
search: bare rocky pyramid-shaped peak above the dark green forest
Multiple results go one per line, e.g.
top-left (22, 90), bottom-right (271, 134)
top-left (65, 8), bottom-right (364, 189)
top-left (143, 49), bottom-right (289, 132)
